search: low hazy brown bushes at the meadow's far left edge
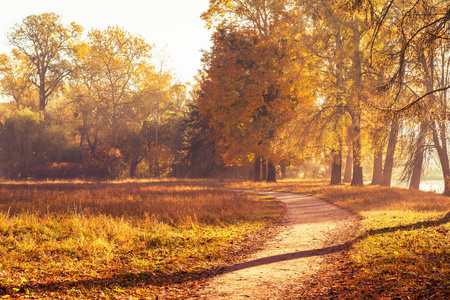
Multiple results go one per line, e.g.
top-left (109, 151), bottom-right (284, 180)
top-left (0, 109), bottom-right (123, 179)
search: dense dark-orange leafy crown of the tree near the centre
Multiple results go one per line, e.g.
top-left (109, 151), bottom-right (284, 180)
top-left (199, 26), bottom-right (306, 164)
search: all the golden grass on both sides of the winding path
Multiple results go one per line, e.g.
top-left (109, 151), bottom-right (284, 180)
top-left (0, 180), bottom-right (450, 299)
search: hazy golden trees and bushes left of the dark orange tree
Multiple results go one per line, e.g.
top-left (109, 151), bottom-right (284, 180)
top-left (0, 13), bottom-right (188, 178)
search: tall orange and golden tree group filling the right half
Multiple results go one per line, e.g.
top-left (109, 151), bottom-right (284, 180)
top-left (197, 0), bottom-right (450, 194)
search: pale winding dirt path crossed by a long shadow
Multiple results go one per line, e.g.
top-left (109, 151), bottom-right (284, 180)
top-left (201, 191), bottom-right (351, 299)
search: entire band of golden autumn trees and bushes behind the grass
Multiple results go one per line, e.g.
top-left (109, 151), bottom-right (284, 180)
top-left (0, 0), bottom-right (450, 195)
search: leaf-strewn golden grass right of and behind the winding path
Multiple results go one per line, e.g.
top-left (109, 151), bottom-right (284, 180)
top-left (230, 181), bottom-right (450, 299)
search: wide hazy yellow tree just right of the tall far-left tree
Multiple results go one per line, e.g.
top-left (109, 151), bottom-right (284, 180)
top-left (68, 27), bottom-right (186, 177)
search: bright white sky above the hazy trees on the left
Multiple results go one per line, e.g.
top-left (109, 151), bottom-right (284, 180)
top-left (0, 0), bottom-right (211, 82)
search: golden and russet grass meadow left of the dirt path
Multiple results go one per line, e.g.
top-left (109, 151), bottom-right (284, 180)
top-left (0, 180), bottom-right (283, 299)
